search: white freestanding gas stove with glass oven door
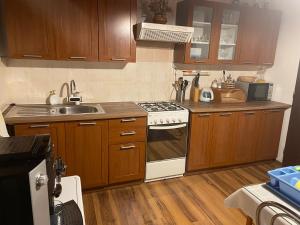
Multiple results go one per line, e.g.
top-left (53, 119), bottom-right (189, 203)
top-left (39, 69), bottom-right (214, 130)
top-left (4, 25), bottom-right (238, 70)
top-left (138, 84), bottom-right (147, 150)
top-left (138, 102), bottom-right (189, 182)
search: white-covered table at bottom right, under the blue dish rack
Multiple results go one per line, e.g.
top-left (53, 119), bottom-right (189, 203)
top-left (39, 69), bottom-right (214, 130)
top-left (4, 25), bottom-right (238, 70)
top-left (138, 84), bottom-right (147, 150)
top-left (225, 184), bottom-right (300, 225)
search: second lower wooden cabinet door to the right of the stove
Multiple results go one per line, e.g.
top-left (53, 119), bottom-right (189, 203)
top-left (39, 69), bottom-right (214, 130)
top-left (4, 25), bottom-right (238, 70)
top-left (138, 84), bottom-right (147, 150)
top-left (209, 112), bottom-right (236, 167)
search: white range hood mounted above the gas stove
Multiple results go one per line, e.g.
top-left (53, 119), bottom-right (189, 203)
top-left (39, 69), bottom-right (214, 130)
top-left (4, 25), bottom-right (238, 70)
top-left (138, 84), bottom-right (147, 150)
top-left (136, 23), bottom-right (194, 43)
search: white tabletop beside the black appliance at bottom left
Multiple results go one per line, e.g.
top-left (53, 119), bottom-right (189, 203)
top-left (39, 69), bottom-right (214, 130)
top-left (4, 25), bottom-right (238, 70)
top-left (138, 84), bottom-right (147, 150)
top-left (55, 176), bottom-right (85, 225)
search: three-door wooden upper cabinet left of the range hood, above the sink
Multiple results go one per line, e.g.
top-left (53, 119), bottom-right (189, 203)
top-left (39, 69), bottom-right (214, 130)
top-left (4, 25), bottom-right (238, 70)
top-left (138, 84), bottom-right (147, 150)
top-left (1, 0), bottom-right (137, 62)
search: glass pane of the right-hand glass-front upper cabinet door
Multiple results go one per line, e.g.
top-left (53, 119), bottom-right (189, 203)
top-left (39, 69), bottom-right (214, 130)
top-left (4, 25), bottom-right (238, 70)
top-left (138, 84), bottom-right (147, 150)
top-left (218, 9), bottom-right (240, 61)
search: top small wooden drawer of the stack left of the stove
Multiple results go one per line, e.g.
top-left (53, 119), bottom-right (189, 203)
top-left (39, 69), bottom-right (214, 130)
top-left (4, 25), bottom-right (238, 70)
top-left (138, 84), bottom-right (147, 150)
top-left (109, 117), bottom-right (147, 129)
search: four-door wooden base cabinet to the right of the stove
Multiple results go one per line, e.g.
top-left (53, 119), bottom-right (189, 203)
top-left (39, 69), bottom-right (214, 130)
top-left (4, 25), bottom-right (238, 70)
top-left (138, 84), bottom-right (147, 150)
top-left (187, 109), bottom-right (284, 171)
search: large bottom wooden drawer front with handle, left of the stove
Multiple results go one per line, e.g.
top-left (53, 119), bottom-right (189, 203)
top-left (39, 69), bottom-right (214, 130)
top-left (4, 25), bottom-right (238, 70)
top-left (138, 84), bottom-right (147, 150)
top-left (109, 142), bottom-right (145, 184)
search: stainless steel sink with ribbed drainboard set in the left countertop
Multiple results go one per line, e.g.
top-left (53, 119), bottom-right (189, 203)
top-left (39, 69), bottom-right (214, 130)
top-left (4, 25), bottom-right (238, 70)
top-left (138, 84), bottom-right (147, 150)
top-left (5, 104), bottom-right (105, 118)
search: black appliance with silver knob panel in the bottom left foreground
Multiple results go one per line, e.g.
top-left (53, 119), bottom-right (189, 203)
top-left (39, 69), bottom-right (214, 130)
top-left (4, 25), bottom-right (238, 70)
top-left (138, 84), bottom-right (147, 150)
top-left (0, 135), bottom-right (55, 225)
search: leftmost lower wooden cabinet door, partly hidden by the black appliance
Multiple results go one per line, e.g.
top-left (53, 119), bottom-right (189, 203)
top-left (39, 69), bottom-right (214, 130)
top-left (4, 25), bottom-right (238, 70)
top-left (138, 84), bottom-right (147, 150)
top-left (14, 123), bottom-right (65, 159)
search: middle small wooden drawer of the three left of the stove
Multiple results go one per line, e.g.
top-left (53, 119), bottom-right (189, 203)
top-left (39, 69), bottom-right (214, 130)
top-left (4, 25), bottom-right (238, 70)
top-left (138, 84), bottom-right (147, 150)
top-left (109, 127), bottom-right (146, 144)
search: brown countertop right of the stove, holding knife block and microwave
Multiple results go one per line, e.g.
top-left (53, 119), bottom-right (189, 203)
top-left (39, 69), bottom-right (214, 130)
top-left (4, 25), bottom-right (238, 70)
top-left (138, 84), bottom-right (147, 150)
top-left (180, 101), bottom-right (291, 113)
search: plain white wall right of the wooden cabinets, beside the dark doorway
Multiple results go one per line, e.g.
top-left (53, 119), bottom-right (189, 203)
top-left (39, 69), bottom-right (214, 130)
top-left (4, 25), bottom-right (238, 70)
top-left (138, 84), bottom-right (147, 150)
top-left (266, 0), bottom-right (300, 161)
